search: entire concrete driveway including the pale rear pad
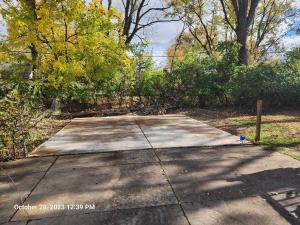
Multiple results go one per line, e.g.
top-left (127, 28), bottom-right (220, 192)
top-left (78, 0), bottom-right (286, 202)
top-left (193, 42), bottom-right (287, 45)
top-left (0, 115), bottom-right (300, 225)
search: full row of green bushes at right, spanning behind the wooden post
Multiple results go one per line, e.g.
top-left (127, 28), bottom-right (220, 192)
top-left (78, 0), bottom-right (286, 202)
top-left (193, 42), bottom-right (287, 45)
top-left (166, 43), bottom-right (300, 108)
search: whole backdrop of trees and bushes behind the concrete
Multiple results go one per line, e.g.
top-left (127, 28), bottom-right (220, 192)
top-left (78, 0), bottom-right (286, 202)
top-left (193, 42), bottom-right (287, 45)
top-left (0, 0), bottom-right (300, 158)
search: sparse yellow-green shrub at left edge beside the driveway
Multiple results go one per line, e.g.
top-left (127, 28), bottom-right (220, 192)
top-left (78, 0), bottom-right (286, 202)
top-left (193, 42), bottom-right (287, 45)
top-left (0, 90), bottom-right (43, 159)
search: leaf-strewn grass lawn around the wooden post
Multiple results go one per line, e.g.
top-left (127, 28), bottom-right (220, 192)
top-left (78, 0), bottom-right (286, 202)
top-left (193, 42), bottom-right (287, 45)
top-left (190, 108), bottom-right (300, 160)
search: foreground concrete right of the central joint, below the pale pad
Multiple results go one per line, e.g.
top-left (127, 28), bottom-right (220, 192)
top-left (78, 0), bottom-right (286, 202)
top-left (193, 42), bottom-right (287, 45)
top-left (162, 146), bottom-right (300, 225)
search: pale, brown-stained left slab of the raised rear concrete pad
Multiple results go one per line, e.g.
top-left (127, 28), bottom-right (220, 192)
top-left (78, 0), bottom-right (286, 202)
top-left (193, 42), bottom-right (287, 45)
top-left (30, 117), bottom-right (151, 156)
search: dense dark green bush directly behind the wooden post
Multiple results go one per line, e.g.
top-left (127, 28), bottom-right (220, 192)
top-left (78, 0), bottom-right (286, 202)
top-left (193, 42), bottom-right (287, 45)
top-left (229, 64), bottom-right (300, 107)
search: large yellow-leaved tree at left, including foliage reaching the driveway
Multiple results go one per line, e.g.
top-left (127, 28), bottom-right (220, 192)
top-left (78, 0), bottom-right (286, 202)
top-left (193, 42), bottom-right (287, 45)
top-left (0, 0), bottom-right (131, 158)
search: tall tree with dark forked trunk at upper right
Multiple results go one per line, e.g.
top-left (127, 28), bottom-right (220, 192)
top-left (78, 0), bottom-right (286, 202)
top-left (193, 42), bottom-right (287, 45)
top-left (220, 0), bottom-right (296, 64)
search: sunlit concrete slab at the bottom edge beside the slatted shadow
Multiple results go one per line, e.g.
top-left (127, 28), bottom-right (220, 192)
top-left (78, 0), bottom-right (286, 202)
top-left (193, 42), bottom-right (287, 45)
top-left (183, 197), bottom-right (289, 225)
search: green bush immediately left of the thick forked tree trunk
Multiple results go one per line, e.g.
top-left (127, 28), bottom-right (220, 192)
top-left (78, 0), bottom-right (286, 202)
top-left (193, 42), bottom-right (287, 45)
top-left (162, 42), bottom-right (238, 107)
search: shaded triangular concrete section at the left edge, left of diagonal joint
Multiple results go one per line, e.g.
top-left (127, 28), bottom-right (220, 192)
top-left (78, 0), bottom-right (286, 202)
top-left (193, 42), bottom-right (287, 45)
top-left (0, 172), bottom-right (44, 223)
